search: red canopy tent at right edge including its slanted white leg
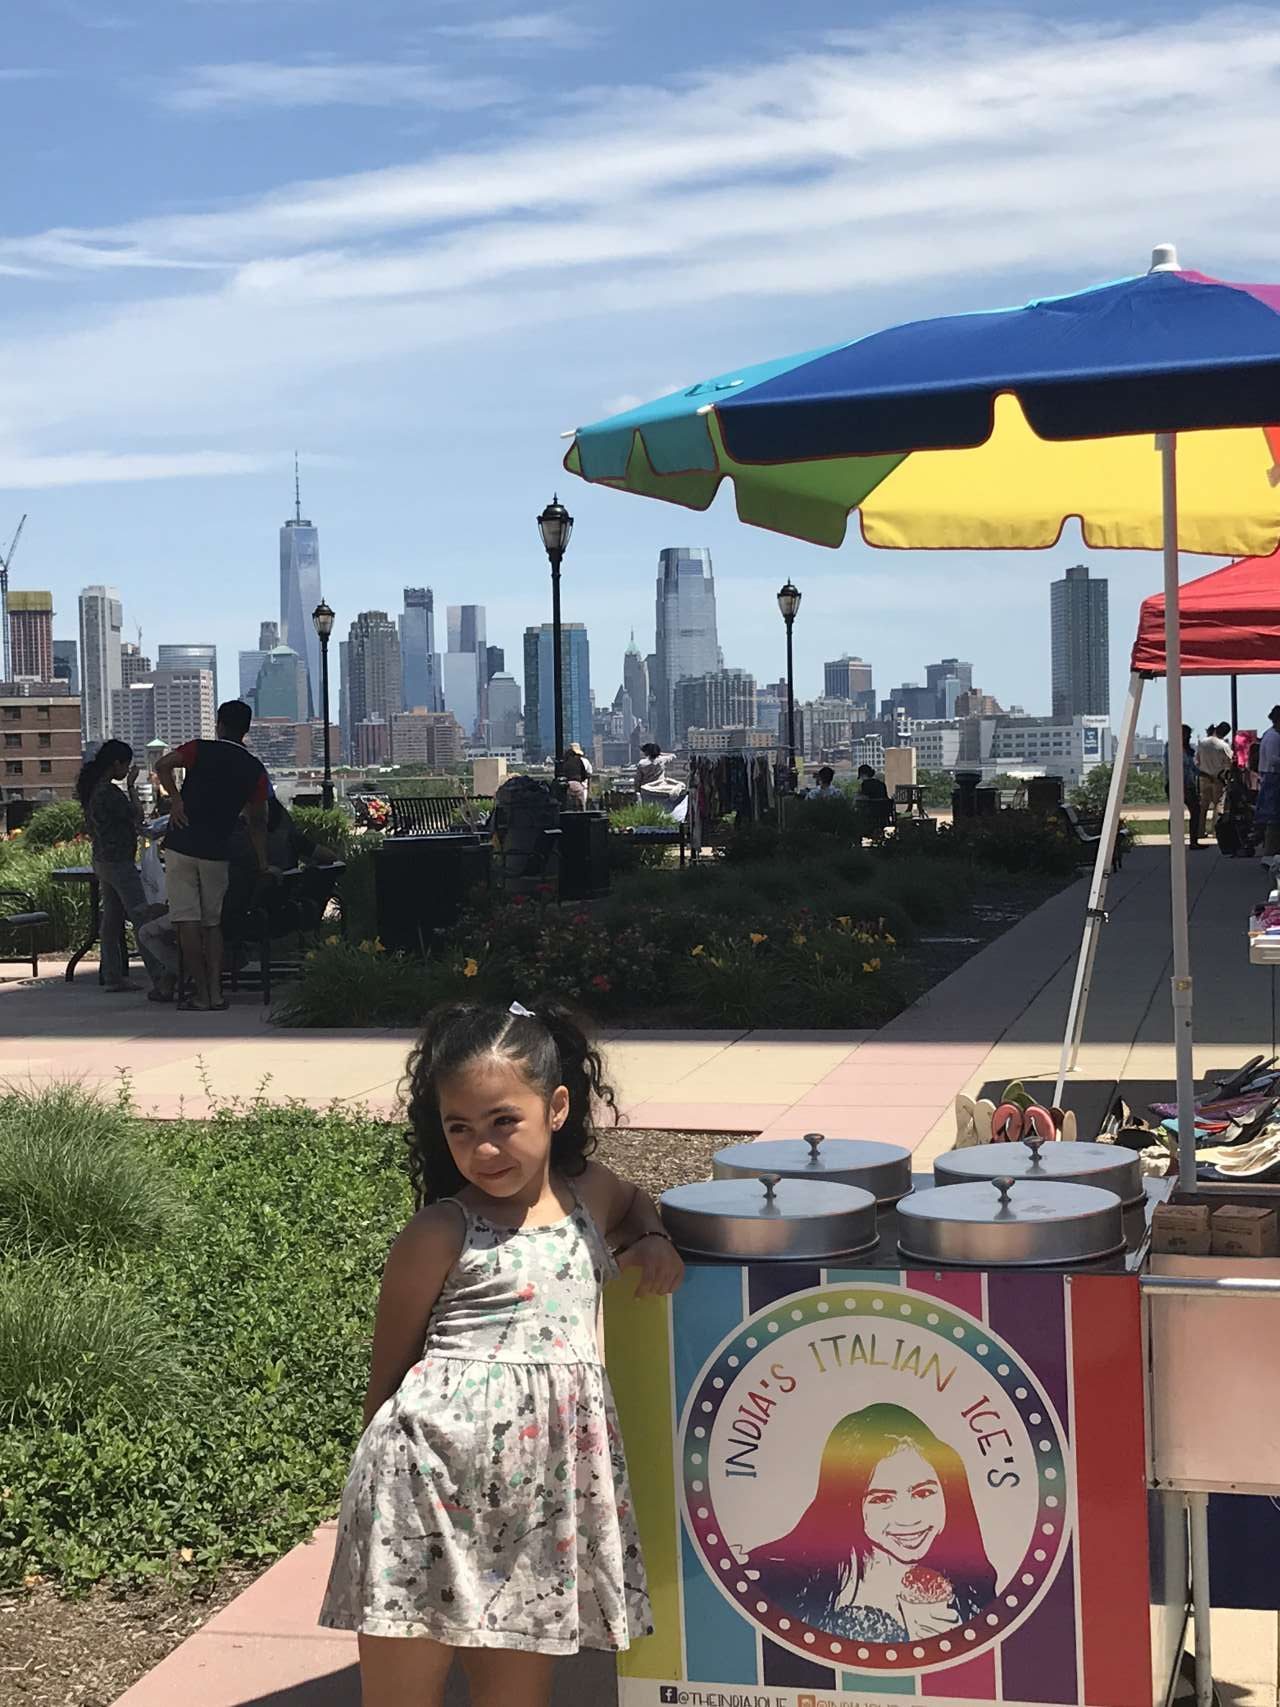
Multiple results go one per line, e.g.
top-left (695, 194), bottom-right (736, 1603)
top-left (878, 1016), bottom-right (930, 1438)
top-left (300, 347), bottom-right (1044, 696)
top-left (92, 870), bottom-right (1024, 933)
top-left (1055, 551), bottom-right (1280, 1103)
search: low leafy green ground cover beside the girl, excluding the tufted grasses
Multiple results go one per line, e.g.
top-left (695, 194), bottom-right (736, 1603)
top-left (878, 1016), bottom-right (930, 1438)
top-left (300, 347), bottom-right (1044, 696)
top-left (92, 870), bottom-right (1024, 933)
top-left (0, 1104), bottom-right (413, 1588)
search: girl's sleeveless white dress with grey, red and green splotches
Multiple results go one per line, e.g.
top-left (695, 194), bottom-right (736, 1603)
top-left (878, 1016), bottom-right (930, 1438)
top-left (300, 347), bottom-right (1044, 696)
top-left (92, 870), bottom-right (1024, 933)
top-left (319, 1200), bottom-right (652, 1654)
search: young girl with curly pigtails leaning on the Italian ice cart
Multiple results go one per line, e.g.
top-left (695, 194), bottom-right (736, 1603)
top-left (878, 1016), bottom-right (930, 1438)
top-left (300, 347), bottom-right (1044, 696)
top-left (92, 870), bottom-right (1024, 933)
top-left (321, 1002), bottom-right (683, 1707)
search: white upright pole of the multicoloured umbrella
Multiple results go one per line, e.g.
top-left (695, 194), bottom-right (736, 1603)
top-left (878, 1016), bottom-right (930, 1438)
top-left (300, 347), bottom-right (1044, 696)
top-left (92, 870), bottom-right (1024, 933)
top-left (1157, 432), bottom-right (1196, 1191)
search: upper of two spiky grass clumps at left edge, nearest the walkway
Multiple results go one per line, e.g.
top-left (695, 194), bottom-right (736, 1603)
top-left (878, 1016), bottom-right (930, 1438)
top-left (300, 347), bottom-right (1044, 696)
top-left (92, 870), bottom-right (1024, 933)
top-left (0, 1084), bottom-right (179, 1256)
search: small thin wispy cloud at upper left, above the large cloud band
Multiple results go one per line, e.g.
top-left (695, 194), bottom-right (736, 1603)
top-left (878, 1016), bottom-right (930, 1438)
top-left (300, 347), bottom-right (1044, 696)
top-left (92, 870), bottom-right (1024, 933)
top-left (159, 60), bottom-right (510, 113)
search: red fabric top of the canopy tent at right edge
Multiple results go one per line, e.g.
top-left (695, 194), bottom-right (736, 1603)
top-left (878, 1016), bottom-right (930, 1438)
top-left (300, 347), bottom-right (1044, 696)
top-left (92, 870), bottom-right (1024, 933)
top-left (1132, 551), bottom-right (1280, 676)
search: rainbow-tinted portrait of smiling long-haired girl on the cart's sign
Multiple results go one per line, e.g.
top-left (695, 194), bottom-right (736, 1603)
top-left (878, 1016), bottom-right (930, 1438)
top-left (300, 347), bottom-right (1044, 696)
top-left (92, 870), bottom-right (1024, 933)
top-left (751, 1405), bottom-right (995, 1642)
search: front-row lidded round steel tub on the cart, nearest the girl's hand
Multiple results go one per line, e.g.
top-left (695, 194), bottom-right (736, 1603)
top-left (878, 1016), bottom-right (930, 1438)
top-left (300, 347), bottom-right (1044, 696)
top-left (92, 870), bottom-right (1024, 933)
top-left (659, 1174), bottom-right (876, 1261)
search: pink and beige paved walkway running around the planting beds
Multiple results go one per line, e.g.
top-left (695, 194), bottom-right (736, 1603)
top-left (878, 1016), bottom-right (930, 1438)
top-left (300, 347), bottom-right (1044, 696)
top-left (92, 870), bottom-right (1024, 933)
top-left (12, 847), bottom-right (1277, 1707)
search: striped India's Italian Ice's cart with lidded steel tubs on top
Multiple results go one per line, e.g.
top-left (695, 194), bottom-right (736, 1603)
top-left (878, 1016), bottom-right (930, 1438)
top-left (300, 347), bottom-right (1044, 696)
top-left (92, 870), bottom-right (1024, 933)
top-left (608, 1140), bottom-right (1188, 1707)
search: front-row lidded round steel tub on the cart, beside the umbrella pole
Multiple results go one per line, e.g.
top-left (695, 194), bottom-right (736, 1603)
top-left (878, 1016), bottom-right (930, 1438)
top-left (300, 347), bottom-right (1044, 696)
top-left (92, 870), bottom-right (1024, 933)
top-left (898, 1176), bottom-right (1125, 1268)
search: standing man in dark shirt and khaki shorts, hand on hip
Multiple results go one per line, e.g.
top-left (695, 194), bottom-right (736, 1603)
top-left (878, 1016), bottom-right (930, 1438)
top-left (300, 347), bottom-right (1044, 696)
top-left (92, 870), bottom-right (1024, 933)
top-left (155, 700), bottom-right (268, 1012)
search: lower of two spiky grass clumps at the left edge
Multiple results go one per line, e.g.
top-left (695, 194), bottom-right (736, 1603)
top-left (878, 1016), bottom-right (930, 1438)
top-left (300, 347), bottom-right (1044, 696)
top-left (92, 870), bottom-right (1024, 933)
top-left (0, 1260), bottom-right (193, 1429)
